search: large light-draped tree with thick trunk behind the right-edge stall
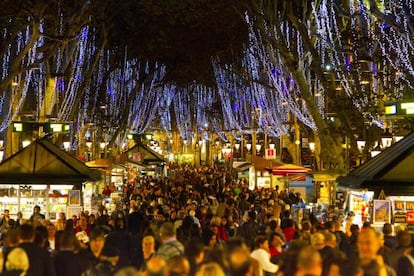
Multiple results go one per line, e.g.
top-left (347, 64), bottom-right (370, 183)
top-left (239, 1), bottom-right (413, 170)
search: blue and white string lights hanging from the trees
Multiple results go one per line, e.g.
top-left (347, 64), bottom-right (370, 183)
top-left (0, 0), bottom-right (414, 144)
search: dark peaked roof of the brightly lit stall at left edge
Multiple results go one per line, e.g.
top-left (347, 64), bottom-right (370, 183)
top-left (0, 138), bottom-right (100, 184)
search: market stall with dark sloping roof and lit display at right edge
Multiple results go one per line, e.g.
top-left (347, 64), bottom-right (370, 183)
top-left (337, 133), bottom-right (414, 229)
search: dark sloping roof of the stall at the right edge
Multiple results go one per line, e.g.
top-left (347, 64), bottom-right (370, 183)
top-left (337, 132), bottom-right (414, 195)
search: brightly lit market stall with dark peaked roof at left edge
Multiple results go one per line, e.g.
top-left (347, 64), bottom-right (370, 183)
top-left (0, 138), bottom-right (100, 219)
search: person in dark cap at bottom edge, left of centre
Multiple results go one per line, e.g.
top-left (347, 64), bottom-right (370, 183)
top-left (82, 246), bottom-right (120, 276)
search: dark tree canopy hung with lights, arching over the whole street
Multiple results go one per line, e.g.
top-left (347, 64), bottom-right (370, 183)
top-left (0, 0), bottom-right (414, 171)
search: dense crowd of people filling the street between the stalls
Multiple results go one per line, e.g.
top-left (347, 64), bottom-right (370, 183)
top-left (0, 165), bottom-right (414, 276)
